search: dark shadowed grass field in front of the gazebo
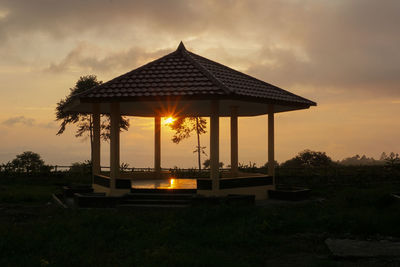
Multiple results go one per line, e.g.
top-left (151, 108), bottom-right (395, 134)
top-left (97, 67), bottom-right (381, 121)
top-left (0, 178), bottom-right (400, 266)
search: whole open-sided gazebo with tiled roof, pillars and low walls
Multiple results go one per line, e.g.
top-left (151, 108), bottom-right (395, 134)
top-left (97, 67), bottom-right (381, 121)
top-left (65, 42), bottom-right (316, 199)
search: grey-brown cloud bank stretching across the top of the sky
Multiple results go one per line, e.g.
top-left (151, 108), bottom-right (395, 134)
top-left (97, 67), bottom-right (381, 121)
top-left (0, 0), bottom-right (400, 94)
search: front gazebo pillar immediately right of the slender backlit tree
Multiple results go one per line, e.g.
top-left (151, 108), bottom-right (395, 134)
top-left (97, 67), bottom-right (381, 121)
top-left (210, 100), bottom-right (219, 193)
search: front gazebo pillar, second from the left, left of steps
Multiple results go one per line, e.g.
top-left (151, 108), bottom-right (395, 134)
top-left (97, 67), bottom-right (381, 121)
top-left (110, 102), bottom-right (121, 192)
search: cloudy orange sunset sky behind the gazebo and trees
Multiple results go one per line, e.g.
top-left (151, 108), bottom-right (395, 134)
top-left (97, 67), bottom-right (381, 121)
top-left (0, 0), bottom-right (400, 167)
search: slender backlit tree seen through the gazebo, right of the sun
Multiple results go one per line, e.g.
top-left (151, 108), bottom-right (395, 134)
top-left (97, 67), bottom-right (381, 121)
top-left (170, 117), bottom-right (207, 171)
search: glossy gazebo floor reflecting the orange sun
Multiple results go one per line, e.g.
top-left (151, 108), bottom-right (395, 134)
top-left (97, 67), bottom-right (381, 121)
top-left (131, 178), bottom-right (197, 189)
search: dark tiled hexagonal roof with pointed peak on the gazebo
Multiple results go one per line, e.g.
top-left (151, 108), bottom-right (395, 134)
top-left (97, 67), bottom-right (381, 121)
top-left (79, 42), bottom-right (316, 106)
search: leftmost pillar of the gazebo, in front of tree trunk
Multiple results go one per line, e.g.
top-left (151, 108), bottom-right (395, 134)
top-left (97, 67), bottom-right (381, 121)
top-left (92, 103), bottom-right (101, 175)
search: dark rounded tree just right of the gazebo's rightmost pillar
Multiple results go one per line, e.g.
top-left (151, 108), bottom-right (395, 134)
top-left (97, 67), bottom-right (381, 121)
top-left (282, 149), bottom-right (333, 168)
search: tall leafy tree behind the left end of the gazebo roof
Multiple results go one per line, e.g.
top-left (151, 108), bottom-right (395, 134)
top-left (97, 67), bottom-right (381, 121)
top-left (56, 75), bottom-right (129, 163)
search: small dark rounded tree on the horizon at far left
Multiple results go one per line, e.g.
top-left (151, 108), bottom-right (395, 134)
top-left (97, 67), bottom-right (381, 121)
top-left (11, 151), bottom-right (45, 173)
